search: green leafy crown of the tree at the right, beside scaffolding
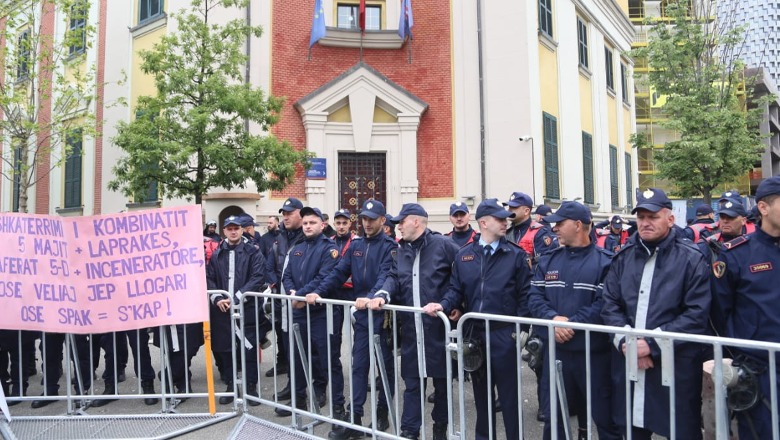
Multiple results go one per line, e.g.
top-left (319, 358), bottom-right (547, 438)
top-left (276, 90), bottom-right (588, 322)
top-left (632, 0), bottom-right (763, 202)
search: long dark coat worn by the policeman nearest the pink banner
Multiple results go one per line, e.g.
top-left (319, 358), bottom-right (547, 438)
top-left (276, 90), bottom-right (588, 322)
top-left (206, 240), bottom-right (268, 351)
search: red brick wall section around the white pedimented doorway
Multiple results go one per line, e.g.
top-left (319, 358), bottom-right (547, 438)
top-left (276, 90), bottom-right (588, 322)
top-left (266, 0), bottom-right (454, 198)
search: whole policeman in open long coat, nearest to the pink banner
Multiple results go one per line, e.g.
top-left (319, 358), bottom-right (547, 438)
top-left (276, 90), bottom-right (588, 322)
top-left (206, 216), bottom-right (271, 405)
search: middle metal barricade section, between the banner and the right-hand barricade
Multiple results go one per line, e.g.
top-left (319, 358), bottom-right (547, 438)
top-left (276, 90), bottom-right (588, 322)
top-left (240, 291), bottom-right (455, 438)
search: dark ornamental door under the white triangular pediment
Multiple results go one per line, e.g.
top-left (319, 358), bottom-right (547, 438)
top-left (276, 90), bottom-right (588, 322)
top-left (338, 153), bottom-right (387, 231)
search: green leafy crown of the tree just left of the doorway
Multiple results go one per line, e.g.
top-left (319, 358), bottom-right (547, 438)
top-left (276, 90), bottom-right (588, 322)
top-left (109, 0), bottom-right (309, 203)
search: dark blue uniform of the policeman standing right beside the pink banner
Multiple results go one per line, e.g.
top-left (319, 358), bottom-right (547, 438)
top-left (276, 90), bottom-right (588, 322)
top-left (206, 230), bottom-right (271, 388)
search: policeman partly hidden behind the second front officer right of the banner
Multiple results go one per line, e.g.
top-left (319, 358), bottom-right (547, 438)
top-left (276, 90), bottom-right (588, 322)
top-left (265, 197), bottom-right (304, 390)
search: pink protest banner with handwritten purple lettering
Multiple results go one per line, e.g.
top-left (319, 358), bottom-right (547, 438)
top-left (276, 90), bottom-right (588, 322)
top-left (0, 205), bottom-right (209, 333)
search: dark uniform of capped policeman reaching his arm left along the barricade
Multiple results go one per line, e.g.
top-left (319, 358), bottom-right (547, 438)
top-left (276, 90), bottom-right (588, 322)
top-left (315, 227), bottom-right (398, 417)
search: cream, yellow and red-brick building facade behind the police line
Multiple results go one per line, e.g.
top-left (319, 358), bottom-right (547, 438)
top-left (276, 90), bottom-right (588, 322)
top-left (0, 0), bottom-right (637, 230)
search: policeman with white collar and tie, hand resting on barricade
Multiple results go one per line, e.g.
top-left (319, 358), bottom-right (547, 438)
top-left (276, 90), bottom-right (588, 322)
top-left (425, 199), bottom-right (531, 440)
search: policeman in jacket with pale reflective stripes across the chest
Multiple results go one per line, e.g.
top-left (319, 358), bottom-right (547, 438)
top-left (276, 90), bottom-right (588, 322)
top-left (528, 202), bottom-right (622, 440)
